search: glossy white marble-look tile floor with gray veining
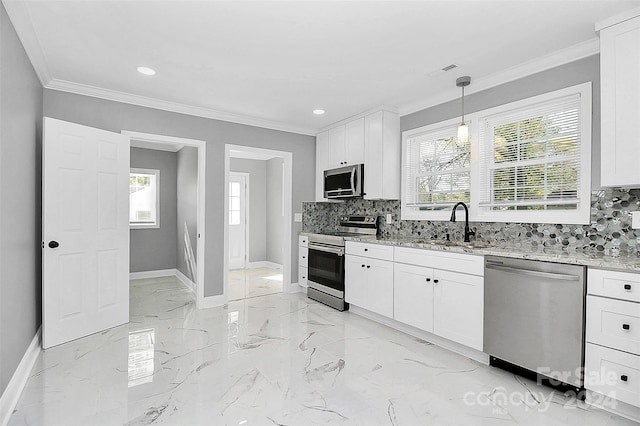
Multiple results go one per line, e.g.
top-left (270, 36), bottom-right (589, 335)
top-left (10, 279), bottom-right (633, 425)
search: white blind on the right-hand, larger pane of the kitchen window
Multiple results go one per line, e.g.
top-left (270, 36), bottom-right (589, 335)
top-left (478, 93), bottom-right (589, 212)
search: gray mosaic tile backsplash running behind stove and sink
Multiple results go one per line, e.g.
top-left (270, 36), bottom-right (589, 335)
top-left (302, 189), bottom-right (640, 256)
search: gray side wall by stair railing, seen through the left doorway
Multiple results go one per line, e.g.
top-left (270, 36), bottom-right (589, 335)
top-left (176, 146), bottom-right (198, 282)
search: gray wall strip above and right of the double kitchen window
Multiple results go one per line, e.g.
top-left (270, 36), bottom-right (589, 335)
top-left (400, 55), bottom-right (600, 189)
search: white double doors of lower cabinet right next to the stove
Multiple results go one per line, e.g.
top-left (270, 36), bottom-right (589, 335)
top-left (344, 254), bottom-right (393, 318)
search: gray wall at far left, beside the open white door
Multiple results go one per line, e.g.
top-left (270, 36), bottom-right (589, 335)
top-left (0, 5), bottom-right (42, 394)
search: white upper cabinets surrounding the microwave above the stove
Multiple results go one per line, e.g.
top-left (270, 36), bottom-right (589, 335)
top-left (316, 106), bottom-right (401, 201)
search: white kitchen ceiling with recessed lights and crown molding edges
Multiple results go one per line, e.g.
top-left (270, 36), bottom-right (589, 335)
top-left (3, 0), bottom-right (640, 134)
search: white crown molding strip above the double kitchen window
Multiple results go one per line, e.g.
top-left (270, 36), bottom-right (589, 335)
top-left (400, 37), bottom-right (600, 117)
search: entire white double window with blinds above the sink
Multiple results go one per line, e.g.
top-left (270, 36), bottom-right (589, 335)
top-left (401, 83), bottom-right (591, 224)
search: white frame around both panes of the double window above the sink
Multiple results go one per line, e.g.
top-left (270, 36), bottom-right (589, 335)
top-left (400, 82), bottom-right (592, 225)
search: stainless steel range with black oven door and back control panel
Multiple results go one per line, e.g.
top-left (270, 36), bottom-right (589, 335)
top-left (307, 216), bottom-right (378, 311)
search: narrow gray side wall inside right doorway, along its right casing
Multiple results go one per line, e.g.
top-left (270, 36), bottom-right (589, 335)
top-left (266, 158), bottom-right (284, 265)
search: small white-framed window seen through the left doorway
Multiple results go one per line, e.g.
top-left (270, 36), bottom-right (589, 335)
top-left (129, 169), bottom-right (160, 228)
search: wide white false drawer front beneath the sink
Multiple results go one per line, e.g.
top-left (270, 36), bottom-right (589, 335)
top-left (393, 247), bottom-right (484, 276)
